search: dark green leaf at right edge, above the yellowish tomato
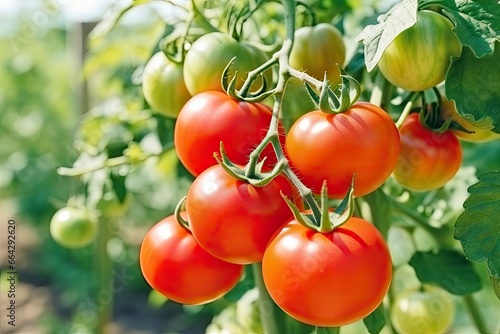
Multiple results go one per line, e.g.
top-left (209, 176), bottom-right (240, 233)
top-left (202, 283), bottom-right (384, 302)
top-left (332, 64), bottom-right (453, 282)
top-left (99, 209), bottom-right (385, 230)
top-left (445, 43), bottom-right (500, 133)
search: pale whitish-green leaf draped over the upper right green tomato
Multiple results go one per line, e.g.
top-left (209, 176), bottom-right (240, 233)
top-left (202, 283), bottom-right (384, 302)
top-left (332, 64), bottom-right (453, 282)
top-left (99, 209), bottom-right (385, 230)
top-left (356, 0), bottom-right (418, 72)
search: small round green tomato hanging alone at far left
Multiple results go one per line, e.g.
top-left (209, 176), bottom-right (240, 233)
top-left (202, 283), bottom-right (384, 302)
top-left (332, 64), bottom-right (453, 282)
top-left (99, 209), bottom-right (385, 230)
top-left (50, 207), bottom-right (99, 248)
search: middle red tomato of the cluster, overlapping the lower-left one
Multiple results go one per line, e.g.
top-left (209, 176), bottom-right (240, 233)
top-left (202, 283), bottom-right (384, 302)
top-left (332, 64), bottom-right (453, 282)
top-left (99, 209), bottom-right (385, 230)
top-left (186, 165), bottom-right (294, 264)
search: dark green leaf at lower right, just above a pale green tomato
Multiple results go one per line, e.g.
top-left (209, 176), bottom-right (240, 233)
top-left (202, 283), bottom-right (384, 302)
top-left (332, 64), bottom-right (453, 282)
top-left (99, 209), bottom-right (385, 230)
top-left (409, 250), bottom-right (481, 295)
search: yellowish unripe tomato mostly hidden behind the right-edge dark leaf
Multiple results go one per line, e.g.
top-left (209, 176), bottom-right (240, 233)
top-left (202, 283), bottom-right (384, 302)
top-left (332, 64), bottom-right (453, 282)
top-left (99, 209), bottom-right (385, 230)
top-left (441, 98), bottom-right (500, 142)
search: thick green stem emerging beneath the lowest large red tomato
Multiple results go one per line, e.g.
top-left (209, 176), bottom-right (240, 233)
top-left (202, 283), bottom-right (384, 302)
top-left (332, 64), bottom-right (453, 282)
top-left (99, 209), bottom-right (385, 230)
top-left (252, 263), bottom-right (286, 334)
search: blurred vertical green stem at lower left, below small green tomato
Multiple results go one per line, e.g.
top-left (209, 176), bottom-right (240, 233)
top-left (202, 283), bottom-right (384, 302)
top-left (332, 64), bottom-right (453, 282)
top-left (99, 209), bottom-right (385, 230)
top-left (95, 218), bottom-right (114, 334)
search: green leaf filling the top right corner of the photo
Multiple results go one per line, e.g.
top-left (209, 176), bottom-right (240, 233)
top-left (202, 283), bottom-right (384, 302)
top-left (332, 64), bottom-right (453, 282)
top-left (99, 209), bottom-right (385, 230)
top-left (422, 0), bottom-right (500, 58)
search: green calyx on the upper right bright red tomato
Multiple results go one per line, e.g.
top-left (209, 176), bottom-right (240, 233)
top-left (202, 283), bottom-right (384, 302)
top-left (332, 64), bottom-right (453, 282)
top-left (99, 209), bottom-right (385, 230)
top-left (304, 64), bottom-right (361, 114)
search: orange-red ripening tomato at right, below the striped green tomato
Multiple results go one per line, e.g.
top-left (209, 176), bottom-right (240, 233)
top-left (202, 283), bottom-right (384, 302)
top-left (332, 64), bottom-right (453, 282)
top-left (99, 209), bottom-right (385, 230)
top-left (393, 113), bottom-right (462, 191)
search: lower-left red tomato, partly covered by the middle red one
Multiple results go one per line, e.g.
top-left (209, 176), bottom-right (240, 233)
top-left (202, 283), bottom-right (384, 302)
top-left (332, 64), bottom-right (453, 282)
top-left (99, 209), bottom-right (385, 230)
top-left (139, 212), bottom-right (243, 305)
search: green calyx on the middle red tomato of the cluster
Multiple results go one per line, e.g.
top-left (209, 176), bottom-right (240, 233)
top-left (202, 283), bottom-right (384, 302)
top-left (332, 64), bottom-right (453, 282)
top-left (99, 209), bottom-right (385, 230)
top-left (214, 142), bottom-right (288, 187)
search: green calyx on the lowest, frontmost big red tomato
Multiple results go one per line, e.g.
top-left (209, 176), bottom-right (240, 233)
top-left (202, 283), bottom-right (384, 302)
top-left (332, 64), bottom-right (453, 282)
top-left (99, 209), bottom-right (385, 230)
top-left (281, 175), bottom-right (355, 233)
